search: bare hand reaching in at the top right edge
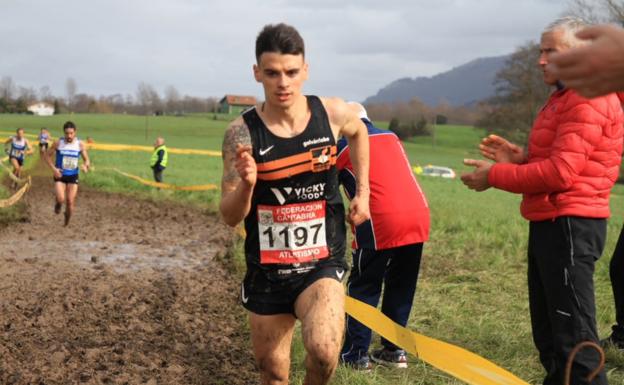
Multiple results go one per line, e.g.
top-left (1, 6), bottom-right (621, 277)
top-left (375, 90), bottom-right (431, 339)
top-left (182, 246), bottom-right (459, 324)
top-left (547, 25), bottom-right (624, 98)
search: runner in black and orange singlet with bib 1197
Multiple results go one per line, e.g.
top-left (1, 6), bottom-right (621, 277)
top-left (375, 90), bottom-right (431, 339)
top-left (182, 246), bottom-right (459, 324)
top-left (220, 24), bottom-right (370, 385)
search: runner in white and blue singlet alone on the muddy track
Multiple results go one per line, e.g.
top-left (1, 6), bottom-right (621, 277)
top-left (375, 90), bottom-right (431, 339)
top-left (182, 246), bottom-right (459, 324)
top-left (44, 121), bottom-right (91, 226)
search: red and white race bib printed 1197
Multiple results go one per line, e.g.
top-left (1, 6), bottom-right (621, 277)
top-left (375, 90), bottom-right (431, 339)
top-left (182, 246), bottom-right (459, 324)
top-left (258, 200), bottom-right (329, 264)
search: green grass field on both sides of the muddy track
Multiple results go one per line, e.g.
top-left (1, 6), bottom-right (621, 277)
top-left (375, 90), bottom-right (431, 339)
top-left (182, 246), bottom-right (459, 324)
top-left (0, 115), bottom-right (624, 385)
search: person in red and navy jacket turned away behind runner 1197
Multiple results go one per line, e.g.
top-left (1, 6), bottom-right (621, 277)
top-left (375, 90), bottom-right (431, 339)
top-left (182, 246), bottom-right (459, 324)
top-left (336, 103), bottom-right (429, 370)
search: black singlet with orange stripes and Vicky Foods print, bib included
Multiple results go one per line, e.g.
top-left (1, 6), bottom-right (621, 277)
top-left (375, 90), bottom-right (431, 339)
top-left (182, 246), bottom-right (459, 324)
top-left (243, 96), bottom-right (345, 280)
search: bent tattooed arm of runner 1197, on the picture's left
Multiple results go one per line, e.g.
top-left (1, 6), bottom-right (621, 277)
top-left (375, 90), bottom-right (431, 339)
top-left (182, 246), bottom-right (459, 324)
top-left (219, 118), bottom-right (257, 226)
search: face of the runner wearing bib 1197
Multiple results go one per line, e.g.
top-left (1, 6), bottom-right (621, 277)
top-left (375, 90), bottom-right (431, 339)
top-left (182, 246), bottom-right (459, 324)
top-left (254, 52), bottom-right (308, 108)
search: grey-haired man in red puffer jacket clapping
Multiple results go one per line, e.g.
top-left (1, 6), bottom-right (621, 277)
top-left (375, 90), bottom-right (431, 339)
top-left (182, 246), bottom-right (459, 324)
top-left (462, 18), bottom-right (624, 385)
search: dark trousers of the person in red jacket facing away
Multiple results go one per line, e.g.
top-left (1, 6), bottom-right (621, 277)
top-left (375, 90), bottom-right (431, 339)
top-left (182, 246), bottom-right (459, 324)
top-left (341, 243), bottom-right (423, 362)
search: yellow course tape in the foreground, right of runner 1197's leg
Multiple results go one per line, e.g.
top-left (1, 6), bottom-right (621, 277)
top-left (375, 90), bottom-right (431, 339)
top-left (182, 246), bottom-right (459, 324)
top-left (345, 297), bottom-right (529, 385)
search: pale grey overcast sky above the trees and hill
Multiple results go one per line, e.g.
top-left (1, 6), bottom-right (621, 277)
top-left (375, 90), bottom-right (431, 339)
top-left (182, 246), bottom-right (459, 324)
top-left (0, 0), bottom-right (567, 100)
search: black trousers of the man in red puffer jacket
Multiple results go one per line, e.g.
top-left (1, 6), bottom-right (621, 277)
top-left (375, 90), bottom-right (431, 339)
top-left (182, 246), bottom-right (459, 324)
top-left (528, 217), bottom-right (607, 385)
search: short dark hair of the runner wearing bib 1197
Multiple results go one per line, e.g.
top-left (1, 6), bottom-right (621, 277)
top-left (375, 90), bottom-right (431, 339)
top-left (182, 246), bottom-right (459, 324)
top-left (256, 23), bottom-right (305, 63)
